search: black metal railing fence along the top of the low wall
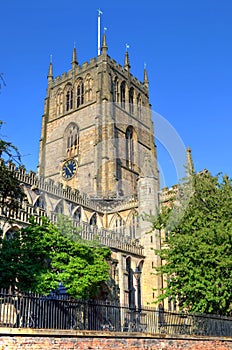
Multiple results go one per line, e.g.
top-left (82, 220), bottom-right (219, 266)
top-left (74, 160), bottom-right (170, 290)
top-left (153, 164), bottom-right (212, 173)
top-left (0, 290), bottom-right (232, 337)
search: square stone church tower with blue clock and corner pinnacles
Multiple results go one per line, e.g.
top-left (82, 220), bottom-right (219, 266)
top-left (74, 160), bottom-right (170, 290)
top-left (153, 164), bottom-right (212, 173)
top-left (39, 34), bottom-right (157, 200)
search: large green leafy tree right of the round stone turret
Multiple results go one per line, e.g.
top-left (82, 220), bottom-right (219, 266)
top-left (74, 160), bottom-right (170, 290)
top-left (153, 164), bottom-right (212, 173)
top-left (153, 171), bottom-right (232, 315)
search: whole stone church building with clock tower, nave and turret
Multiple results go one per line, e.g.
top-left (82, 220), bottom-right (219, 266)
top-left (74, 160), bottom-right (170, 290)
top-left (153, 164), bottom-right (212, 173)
top-left (1, 34), bottom-right (184, 306)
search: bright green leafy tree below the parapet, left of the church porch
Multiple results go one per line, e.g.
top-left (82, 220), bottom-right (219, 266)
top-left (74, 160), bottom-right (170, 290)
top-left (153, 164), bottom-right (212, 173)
top-left (0, 218), bottom-right (110, 299)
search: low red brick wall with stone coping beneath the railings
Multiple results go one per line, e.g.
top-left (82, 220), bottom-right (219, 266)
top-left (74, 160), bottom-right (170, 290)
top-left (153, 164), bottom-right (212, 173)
top-left (0, 328), bottom-right (232, 350)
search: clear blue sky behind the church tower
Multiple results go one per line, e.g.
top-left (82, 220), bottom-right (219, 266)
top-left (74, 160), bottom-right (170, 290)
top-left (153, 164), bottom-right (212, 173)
top-left (0, 0), bottom-right (232, 186)
